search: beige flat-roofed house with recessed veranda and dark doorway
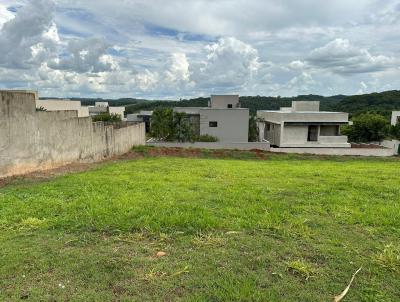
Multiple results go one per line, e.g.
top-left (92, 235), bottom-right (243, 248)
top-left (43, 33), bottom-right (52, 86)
top-left (257, 101), bottom-right (351, 148)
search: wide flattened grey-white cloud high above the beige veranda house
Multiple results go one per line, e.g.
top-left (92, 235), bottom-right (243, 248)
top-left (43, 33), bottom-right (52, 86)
top-left (307, 39), bottom-right (395, 75)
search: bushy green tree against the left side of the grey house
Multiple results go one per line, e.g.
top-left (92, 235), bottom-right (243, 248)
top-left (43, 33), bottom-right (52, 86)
top-left (151, 108), bottom-right (174, 139)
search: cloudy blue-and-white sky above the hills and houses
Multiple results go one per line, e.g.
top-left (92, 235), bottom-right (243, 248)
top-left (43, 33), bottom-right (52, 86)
top-left (0, 0), bottom-right (400, 99)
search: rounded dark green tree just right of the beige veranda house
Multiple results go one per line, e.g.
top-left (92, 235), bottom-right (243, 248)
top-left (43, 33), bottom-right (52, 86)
top-left (342, 113), bottom-right (390, 143)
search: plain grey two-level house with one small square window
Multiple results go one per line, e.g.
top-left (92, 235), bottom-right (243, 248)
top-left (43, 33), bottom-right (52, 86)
top-left (174, 95), bottom-right (249, 143)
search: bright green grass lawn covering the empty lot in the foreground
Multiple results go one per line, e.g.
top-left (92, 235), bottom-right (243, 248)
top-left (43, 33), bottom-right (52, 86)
top-left (0, 156), bottom-right (400, 302)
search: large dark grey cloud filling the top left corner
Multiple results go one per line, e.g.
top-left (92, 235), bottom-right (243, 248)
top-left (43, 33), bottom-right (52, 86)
top-left (0, 0), bottom-right (55, 69)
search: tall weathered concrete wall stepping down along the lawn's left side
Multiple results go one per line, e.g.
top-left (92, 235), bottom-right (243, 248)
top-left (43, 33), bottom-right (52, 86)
top-left (0, 91), bottom-right (145, 177)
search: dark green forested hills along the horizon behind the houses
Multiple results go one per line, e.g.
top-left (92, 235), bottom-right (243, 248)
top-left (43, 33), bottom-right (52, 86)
top-left (41, 90), bottom-right (400, 117)
